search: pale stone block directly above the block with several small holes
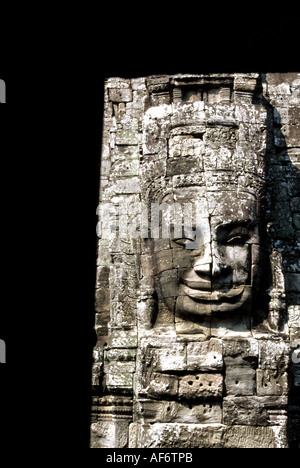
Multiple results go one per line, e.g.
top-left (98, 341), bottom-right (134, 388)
top-left (187, 338), bottom-right (223, 371)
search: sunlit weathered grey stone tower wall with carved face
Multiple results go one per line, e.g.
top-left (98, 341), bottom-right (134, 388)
top-left (91, 73), bottom-right (300, 449)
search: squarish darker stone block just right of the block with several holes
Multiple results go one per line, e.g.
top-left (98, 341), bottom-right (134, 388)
top-left (225, 366), bottom-right (256, 396)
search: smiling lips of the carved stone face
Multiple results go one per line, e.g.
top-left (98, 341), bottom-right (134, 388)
top-left (181, 284), bottom-right (245, 302)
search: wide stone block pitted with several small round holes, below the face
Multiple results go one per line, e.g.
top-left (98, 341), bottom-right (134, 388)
top-left (178, 373), bottom-right (223, 400)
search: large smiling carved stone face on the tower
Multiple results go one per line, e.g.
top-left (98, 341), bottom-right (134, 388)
top-left (156, 187), bottom-right (259, 318)
